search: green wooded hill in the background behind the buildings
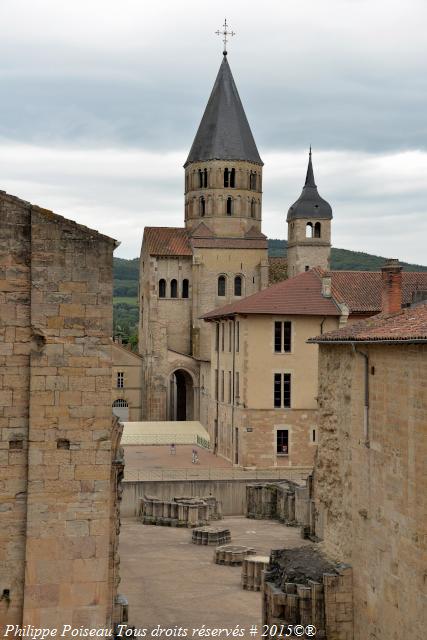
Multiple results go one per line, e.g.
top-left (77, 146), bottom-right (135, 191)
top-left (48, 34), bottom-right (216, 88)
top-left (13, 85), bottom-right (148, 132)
top-left (114, 239), bottom-right (427, 340)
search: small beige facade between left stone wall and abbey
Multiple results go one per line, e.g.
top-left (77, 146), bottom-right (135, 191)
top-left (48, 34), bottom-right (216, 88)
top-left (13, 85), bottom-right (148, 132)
top-left (111, 342), bottom-right (142, 422)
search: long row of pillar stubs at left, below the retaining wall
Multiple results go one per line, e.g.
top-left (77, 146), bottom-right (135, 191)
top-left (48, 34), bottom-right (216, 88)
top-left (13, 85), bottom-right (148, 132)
top-left (139, 496), bottom-right (222, 528)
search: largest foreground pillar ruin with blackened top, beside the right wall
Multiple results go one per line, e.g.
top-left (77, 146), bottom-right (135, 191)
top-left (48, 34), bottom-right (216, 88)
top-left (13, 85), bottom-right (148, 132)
top-left (262, 546), bottom-right (353, 640)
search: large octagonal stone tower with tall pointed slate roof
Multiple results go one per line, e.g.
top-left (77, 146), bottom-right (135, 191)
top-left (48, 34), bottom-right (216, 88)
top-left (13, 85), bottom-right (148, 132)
top-left (184, 51), bottom-right (263, 238)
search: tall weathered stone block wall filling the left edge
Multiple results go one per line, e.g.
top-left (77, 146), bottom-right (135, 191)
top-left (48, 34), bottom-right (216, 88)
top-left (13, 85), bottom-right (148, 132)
top-left (0, 192), bottom-right (120, 627)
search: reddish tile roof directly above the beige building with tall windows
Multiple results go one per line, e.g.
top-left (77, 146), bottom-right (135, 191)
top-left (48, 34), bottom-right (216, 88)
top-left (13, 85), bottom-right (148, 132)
top-left (202, 270), bottom-right (340, 320)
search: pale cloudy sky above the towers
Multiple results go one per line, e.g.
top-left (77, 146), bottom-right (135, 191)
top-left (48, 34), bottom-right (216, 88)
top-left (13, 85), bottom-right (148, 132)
top-left (0, 0), bottom-right (427, 264)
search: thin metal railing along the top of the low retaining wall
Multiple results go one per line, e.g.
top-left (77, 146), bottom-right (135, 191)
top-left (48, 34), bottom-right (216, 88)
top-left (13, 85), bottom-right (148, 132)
top-left (124, 465), bottom-right (313, 483)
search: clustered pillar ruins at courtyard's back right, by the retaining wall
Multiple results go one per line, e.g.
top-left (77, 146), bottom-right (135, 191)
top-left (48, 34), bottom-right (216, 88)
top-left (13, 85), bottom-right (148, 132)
top-left (246, 476), bottom-right (314, 537)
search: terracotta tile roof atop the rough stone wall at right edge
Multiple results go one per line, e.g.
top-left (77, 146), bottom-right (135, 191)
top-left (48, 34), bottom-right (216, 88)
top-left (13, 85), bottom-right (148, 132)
top-left (308, 302), bottom-right (427, 342)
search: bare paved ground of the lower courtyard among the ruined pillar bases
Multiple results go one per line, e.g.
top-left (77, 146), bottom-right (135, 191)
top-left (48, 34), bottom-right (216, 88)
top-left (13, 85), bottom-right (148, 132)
top-left (119, 516), bottom-right (307, 639)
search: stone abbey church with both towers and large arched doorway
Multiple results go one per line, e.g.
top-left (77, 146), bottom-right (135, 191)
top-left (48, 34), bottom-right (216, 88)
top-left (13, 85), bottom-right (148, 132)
top-left (139, 55), bottom-right (332, 426)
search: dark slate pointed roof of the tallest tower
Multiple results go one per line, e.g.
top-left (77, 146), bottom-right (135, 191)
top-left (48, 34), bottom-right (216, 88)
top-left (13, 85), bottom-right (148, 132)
top-left (184, 55), bottom-right (263, 166)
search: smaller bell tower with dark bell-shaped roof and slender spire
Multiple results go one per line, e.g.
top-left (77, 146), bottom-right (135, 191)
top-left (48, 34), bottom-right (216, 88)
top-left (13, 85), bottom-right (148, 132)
top-left (287, 147), bottom-right (332, 278)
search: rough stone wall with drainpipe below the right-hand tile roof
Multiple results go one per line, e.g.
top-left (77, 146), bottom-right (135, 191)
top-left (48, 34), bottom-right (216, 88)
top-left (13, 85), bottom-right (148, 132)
top-left (315, 344), bottom-right (427, 640)
